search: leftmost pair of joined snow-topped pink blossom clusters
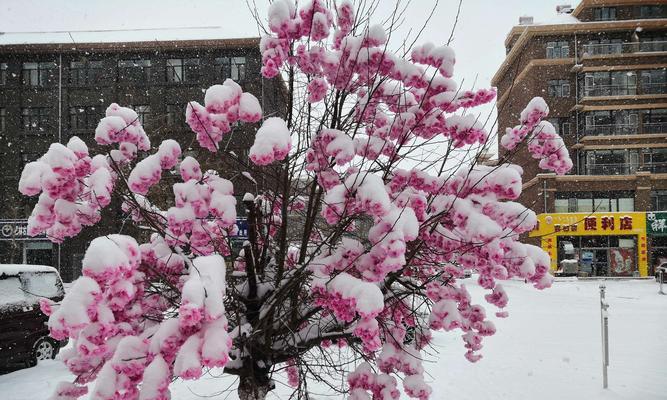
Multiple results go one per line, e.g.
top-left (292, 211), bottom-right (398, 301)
top-left (19, 103), bottom-right (159, 243)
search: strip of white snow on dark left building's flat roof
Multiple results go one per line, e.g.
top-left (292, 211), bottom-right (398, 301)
top-left (0, 26), bottom-right (258, 46)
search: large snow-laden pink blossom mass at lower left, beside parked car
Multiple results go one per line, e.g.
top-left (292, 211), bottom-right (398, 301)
top-left (49, 247), bottom-right (232, 400)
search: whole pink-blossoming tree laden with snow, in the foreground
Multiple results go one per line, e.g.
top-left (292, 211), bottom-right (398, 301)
top-left (19, 0), bottom-right (572, 400)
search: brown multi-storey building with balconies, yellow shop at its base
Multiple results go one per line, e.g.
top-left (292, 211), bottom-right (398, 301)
top-left (493, 0), bottom-right (667, 276)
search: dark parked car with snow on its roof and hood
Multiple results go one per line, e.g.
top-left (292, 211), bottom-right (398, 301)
top-left (0, 264), bottom-right (67, 368)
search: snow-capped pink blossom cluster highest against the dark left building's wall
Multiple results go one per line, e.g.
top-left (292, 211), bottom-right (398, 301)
top-left (185, 79), bottom-right (262, 152)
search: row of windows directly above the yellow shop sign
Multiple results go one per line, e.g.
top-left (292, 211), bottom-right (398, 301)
top-left (554, 191), bottom-right (635, 213)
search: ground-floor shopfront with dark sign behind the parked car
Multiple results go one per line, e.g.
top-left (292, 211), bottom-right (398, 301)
top-left (0, 220), bottom-right (58, 266)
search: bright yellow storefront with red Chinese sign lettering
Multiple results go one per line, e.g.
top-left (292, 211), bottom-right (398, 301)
top-left (529, 212), bottom-right (648, 276)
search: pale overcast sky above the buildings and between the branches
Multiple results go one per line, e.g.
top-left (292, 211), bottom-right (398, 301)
top-left (0, 0), bottom-right (578, 141)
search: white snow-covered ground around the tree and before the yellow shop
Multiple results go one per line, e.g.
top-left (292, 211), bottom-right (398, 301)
top-left (0, 280), bottom-right (667, 400)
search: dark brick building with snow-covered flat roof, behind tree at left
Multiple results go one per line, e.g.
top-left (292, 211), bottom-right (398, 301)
top-left (0, 29), bottom-right (284, 281)
